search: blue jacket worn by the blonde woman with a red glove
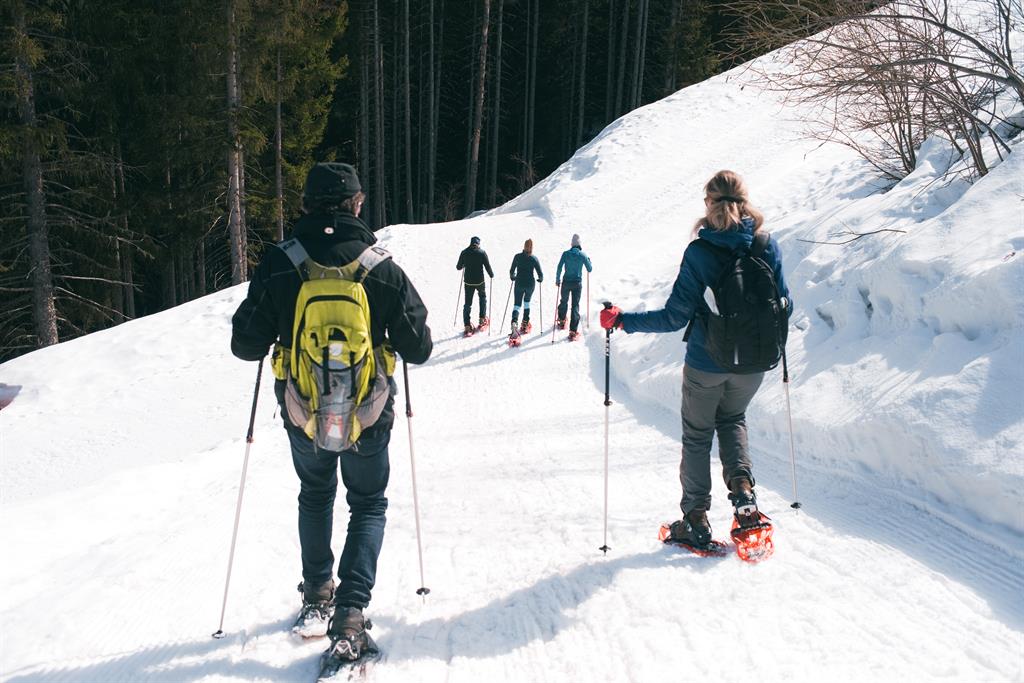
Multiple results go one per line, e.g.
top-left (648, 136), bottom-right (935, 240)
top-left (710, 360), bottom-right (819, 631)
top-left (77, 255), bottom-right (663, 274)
top-left (621, 218), bottom-right (793, 373)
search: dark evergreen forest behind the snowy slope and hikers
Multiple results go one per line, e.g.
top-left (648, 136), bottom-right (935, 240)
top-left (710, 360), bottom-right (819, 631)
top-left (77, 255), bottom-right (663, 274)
top-left (0, 0), bottom-right (786, 361)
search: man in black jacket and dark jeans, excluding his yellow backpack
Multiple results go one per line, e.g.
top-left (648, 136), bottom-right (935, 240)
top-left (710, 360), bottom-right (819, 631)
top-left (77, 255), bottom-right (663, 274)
top-left (231, 163), bottom-right (433, 658)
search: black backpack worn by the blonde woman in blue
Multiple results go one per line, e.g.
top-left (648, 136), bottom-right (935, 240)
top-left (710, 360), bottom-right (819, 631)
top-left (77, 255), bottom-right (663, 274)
top-left (683, 231), bottom-right (790, 375)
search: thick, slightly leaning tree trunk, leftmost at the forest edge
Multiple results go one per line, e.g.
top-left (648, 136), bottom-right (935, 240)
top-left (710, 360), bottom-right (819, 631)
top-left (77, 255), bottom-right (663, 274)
top-left (14, 2), bottom-right (58, 346)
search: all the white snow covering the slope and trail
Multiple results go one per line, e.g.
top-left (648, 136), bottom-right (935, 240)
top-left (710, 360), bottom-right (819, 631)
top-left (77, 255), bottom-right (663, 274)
top-left (0, 26), bottom-right (1024, 683)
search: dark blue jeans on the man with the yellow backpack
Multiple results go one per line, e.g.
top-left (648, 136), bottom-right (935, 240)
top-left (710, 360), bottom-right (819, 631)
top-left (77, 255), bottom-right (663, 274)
top-left (285, 426), bottom-right (391, 608)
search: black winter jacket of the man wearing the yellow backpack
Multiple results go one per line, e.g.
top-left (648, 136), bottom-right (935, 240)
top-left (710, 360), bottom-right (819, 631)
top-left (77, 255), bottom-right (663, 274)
top-left (231, 214), bottom-right (433, 427)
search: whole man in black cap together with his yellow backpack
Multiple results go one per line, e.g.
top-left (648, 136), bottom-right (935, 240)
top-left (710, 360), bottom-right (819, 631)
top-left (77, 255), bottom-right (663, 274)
top-left (231, 162), bottom-right (433, 660)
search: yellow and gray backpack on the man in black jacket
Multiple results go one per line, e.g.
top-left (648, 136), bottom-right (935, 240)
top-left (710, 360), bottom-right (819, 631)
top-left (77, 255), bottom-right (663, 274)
top-left (273, 239), bottom-right (394, 452)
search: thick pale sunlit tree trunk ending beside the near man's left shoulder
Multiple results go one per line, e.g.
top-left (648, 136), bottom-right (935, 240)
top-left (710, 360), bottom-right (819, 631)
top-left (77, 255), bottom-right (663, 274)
top-left (225, 0), bottom-right (246, 282)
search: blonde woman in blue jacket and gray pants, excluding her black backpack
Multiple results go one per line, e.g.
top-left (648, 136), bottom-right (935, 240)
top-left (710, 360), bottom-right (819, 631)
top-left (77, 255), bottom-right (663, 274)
top-left (601, 171), bottom-right (793, 548)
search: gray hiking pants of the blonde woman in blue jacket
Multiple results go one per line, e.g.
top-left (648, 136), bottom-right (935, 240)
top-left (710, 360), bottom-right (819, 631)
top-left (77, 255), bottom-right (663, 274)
top-left (679, 367), bottom-right (765, 515)
